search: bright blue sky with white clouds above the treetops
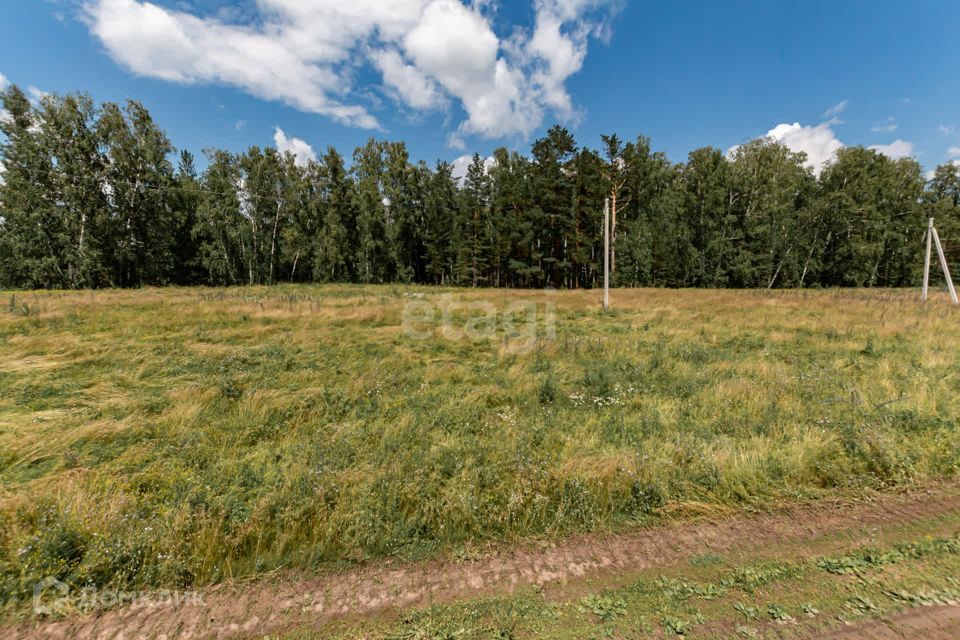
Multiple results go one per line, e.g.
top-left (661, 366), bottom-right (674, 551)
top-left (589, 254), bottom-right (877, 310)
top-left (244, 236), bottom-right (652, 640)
top-left (0, 0), bottom-right (960, 175)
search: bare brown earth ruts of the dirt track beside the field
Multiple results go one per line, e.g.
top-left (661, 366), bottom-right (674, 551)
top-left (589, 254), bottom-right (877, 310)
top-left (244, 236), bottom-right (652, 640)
top-left (11, 487), bottom-right (960, 640)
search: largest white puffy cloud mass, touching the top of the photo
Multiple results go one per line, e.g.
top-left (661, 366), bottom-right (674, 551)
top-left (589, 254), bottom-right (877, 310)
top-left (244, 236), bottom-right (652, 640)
top-left (85, 0), bottom-right (620, 144)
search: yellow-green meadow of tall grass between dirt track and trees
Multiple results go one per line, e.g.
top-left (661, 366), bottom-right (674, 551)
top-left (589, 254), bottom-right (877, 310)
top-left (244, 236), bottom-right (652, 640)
top-left (0, 286), bottom-right (960, 604)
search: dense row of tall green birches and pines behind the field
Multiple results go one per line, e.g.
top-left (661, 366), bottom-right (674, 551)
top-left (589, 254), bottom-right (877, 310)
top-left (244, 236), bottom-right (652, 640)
top-left (0, 86), bottom-right (960, 289)
